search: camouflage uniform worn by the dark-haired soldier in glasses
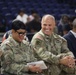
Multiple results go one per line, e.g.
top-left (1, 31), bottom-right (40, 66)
top-left (1, 37), bottom-right (40, 75)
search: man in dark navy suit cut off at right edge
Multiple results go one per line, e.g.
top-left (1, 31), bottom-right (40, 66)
top-left (63, 19), bottom-right (76, 58)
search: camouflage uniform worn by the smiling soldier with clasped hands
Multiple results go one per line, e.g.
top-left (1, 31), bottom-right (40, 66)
top-left (31, 30), bottom-right (76, 75)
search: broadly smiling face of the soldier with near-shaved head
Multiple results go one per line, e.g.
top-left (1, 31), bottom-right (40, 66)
top-left (41, 15), bottom-right (55, 35)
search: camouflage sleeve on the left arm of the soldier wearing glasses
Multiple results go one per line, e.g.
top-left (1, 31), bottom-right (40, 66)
top-left (1, 45), bottom-right (28, 74)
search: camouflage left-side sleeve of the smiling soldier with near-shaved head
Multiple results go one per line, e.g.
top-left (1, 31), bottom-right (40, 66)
top-left (31, 38), bottom-right (60, 64)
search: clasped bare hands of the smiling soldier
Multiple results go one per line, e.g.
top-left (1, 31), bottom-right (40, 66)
top-left (60, 56), bottom-right (76, 68)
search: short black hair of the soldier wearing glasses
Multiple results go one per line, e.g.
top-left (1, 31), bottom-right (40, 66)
top-left (12, 20), bottom-right (26, 30)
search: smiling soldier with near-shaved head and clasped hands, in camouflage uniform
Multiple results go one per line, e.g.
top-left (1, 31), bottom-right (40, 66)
top-left (31, 15), bottom-right (76, 75)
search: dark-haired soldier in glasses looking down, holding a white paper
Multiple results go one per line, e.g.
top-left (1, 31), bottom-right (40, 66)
top-left (1, 21), bottom-right (41, 75)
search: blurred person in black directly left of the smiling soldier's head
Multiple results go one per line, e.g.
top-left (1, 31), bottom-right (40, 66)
top-left (26, 14), bottom-right (41, 33)
